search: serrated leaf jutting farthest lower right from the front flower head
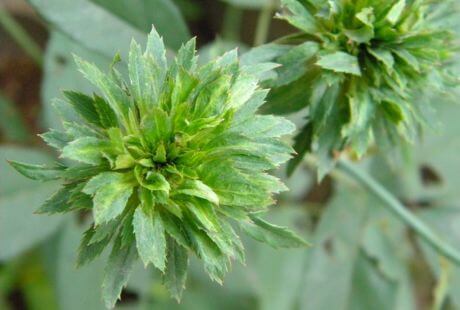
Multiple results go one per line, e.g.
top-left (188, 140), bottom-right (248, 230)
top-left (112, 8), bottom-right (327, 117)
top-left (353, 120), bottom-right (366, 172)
top-left (241, 215), bottom-right (308, 248)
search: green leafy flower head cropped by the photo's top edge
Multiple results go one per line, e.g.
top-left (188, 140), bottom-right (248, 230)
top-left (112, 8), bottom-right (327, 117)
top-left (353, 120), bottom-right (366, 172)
top-left (252, 0), bottom-right (458, 176)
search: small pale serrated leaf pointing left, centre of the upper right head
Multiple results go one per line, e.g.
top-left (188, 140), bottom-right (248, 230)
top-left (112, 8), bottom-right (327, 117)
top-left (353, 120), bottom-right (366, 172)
top-left (316, 52), bottom-right (361, 76)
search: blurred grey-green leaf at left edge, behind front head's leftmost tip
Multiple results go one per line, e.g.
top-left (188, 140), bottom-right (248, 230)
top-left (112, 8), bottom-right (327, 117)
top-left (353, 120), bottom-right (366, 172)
top-left (0, 146), bottom-right (64, 261)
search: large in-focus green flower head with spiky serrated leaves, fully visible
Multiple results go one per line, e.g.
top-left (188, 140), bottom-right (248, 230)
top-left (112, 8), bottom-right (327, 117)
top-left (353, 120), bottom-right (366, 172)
top-left (11, 30), bottom-right (304, 307)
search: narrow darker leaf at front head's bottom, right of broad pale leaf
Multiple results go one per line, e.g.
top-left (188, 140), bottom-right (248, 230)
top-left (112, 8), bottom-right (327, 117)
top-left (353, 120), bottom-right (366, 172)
top-left (163, 238), bottom-right (188, 301)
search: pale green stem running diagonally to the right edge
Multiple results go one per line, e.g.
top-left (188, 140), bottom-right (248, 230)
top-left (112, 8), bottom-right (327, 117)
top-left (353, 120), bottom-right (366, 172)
top-left (337, 160), bottom-right (460, 265)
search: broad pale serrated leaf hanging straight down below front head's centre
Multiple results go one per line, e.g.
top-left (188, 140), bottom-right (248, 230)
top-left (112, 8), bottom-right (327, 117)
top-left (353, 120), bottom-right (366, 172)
top-left (133, 206), bottom-right (166, 272)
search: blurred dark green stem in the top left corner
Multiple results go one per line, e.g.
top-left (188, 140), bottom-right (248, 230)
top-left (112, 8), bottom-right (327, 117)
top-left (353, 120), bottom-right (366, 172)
top-left (0, 9), bottom-right (43, 67)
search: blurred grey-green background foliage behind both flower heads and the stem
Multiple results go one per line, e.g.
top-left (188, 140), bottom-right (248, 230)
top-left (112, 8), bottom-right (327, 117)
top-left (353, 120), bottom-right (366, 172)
top-left (0, 0), bottom-right (460, 310)
